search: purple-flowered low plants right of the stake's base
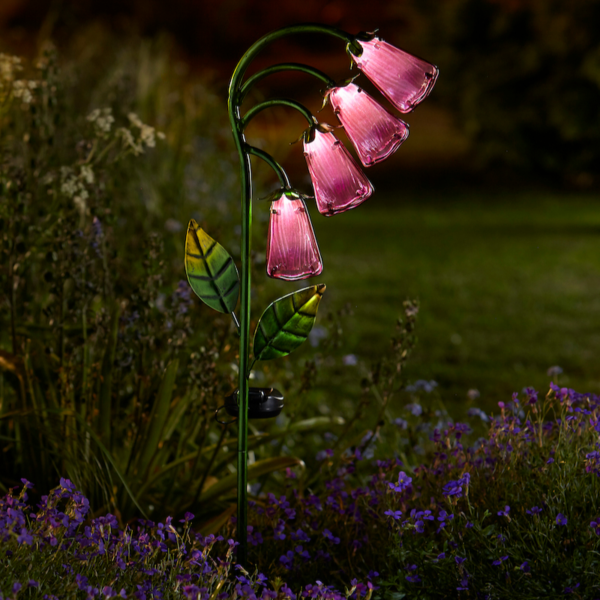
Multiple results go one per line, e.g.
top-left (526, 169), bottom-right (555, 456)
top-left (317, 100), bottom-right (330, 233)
top-left (210, 385), bottom-right (600, 599)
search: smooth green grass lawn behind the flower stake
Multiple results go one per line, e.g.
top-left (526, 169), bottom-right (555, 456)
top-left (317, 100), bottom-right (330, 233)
top-left (288, 189), bottom-right (600, 416)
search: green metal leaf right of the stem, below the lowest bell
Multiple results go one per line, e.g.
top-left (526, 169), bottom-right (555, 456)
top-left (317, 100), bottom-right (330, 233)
top-left (254, 283), bottom-right (325, 360)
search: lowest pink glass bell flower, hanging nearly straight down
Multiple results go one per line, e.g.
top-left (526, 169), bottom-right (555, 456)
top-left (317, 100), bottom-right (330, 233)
top-left (267, 194), bottom-right (323, 281)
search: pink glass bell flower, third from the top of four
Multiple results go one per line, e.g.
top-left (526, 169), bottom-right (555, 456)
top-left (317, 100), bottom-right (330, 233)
top-left (304, 129), bottom-right (374, 216)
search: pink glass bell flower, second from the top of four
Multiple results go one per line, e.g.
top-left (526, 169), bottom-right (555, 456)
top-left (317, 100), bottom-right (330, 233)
top-left (329, 83), bottom-right (408, 167)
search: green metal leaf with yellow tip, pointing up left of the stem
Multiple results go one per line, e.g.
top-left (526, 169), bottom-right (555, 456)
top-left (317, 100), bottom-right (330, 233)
top-left (185, 219), bottom-right (240, 313)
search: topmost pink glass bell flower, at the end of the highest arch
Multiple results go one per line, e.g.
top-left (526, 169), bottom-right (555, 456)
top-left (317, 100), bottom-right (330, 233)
top-left (354, 37), bottom-right (439, 113)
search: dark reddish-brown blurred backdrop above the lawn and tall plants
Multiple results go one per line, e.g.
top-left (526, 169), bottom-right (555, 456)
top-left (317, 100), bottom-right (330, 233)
top-left (0, 0), bottom-right (600, 188)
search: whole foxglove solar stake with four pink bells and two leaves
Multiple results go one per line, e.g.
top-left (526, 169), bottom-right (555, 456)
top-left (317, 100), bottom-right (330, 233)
top-left (185, 24), bottom-right (438, 567)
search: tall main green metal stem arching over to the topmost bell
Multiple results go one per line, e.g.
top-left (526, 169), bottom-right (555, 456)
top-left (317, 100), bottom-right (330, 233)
top-left (228, 23), bottom-right (354, 568)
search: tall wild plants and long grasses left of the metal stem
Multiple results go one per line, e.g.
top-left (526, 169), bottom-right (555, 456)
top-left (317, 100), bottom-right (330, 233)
top-left (0, 36), bottom-right (335, 523)
